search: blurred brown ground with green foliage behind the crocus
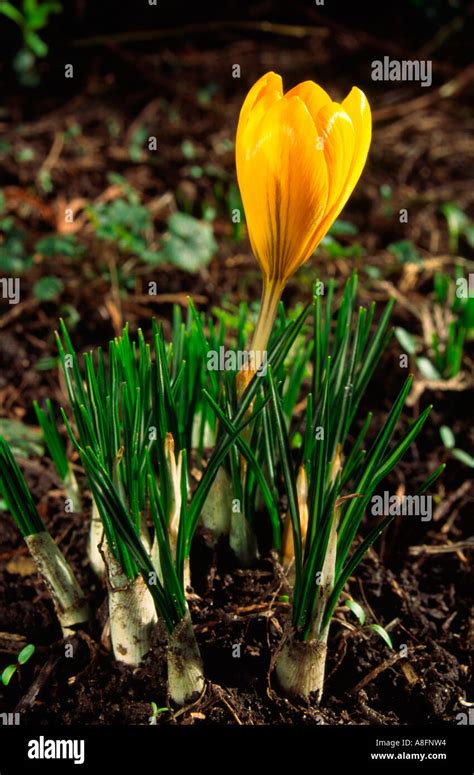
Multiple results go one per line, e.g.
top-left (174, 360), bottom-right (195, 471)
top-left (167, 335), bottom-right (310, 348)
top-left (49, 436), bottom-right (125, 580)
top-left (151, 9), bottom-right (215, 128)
top-left (0, 0), bottom-right (474, 418)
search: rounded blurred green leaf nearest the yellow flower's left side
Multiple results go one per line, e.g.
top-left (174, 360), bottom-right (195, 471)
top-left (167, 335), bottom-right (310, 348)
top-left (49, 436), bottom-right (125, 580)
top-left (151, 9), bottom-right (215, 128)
top-left (163, 213), bottom-right (217, 274)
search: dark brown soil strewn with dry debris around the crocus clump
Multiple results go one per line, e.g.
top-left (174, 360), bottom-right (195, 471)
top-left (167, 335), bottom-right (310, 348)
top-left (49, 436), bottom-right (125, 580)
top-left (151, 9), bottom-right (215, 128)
top-left (0, 3), bottom-right (474, 725)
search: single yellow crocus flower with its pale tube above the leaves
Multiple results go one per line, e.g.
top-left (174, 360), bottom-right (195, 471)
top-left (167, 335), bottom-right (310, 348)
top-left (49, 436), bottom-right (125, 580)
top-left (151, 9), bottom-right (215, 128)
top-left (236, 72), bottom-right (372, 360)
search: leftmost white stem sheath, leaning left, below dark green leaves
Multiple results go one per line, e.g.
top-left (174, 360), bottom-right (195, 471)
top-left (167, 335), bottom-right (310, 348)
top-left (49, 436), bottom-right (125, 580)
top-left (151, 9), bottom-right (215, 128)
top-left (25, 531), bottom-right (89, 637)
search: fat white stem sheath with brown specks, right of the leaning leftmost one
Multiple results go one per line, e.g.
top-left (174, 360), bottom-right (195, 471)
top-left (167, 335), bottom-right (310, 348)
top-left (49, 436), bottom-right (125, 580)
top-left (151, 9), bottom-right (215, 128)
top-left (106, 547), bottom-right (157, 666)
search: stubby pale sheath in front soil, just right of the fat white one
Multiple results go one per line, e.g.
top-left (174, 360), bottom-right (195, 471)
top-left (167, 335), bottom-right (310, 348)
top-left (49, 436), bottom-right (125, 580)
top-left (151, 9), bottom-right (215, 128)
top-left (167, 613), bottom-right (204, 705)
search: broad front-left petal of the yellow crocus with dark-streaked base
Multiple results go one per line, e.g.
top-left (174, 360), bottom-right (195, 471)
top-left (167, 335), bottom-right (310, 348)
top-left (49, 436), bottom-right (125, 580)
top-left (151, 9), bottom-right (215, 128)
top-left (237, 97), bottom-right (328, 279)
